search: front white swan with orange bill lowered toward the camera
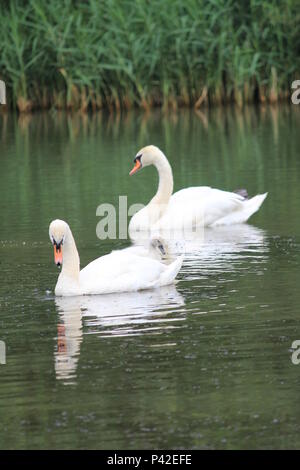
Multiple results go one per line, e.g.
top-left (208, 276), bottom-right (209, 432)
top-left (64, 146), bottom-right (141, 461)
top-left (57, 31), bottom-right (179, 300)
top-left (49, 220), bottom-right (183, 296)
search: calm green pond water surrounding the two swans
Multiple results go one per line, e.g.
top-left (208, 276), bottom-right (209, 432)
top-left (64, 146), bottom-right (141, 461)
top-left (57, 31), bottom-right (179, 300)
top-left (0, 106), bottom-right (300, 449)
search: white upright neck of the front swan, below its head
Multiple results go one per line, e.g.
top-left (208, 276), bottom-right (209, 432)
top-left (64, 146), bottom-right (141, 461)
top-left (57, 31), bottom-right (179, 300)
top-left (56, 228), bottom-right (80, 291)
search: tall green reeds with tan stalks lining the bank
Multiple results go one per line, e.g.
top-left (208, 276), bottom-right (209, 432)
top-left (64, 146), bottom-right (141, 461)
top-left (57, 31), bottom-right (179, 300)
top-left (0, 0), bottom-right (300, 111)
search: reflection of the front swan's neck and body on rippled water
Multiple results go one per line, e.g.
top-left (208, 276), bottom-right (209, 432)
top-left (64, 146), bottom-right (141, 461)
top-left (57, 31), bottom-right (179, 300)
top-left (55, 285), bottom-right (185, 383)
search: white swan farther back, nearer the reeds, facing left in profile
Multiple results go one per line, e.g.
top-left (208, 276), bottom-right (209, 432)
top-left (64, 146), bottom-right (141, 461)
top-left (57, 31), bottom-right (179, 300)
top-left (129, 145), bottom-right (267, 232)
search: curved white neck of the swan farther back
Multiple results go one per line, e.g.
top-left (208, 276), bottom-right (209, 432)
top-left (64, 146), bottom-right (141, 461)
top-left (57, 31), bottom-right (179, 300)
top-left (151, 152), bottom-right (173, 204)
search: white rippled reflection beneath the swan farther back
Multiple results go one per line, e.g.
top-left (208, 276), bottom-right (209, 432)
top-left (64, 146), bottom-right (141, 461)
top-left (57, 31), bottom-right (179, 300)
top-left (131, 224), bottom-right (269, 280)
